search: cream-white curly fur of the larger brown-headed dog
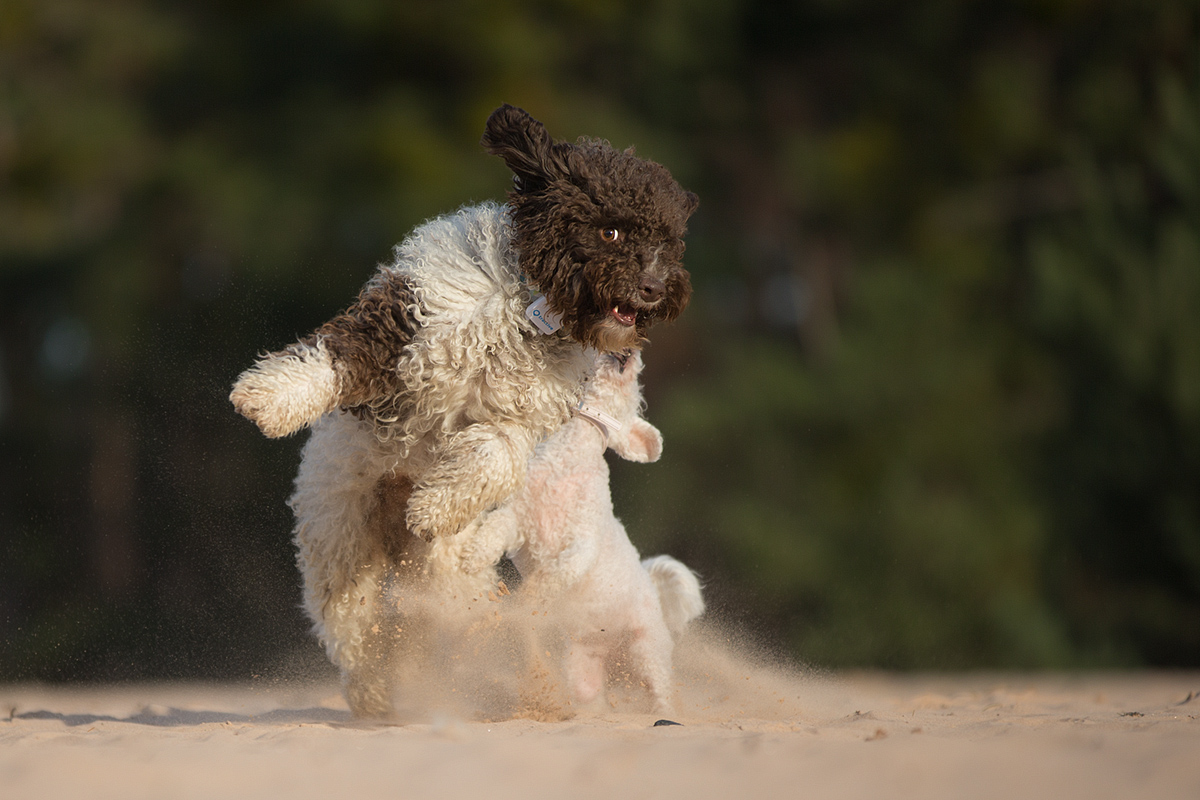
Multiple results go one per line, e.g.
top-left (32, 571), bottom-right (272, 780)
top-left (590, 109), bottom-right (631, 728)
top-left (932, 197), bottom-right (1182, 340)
top-left (243, 203), bottom-right (592, 716)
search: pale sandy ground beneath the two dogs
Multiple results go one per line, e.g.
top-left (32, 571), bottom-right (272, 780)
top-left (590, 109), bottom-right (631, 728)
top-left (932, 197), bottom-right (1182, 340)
top-left (0, 644), bottom-right (1200, 800)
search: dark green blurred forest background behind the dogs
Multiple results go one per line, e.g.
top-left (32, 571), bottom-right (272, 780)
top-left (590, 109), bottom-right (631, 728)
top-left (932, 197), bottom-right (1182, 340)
top-left (0, 0), bottom-right (1200, 680)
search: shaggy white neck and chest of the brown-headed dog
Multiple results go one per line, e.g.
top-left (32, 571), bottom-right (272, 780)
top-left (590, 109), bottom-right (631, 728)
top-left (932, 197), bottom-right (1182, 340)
top-left (374, 204), bottom-right (590, 446)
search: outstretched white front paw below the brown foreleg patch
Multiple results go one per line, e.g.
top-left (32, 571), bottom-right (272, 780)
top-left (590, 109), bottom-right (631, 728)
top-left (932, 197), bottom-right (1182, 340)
top-left (229, 344), bottom-right (340, 439)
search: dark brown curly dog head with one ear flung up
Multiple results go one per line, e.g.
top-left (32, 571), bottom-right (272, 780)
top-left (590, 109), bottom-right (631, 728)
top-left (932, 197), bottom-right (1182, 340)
top-left (482, 106), bottom-right (698, 353)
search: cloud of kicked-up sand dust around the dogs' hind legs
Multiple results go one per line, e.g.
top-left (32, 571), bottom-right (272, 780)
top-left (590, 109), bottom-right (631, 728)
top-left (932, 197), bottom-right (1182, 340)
top-left (279, 590), bottom-right (840, 724)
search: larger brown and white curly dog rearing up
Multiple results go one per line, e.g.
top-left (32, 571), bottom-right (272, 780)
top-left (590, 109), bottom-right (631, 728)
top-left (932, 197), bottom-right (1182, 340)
top-left (230, 106), bottom-right (697, 716)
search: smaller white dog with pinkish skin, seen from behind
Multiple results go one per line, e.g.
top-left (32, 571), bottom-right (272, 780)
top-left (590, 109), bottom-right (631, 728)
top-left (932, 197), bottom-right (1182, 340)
top-left (441, 353), bottom-right (704, 712)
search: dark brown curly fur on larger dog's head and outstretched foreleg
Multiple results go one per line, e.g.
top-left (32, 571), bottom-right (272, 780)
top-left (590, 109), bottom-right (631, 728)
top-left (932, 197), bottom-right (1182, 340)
top-left (258, 106), bottom-right (698, 421)
